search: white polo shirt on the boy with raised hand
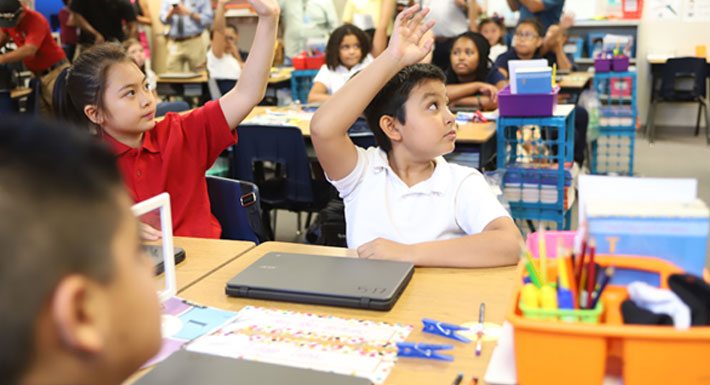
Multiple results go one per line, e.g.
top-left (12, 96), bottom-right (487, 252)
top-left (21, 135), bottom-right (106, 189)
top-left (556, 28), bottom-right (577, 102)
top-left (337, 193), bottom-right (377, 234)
top-left (329, 147), bottom-right (510, 248)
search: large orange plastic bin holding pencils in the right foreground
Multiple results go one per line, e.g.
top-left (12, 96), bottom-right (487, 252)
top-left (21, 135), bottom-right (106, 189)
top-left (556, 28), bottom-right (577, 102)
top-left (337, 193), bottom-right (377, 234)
top-left (507, 249), bottom-right (710, 385)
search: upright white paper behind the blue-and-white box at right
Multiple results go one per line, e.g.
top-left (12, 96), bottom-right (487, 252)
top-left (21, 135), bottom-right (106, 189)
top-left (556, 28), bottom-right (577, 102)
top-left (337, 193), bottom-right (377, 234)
top-left (577, 175), bottom-right (698, 226)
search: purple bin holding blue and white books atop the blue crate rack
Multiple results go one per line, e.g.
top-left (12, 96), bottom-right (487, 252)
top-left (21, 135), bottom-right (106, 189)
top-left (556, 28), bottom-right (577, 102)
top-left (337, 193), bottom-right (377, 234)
top-left (498, 85), bottom-right (560, 116)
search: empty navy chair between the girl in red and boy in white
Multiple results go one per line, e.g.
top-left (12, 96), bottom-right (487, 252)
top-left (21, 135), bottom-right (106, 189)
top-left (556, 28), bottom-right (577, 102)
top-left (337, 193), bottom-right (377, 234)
top-left (232, 125), bottom-right (334, 239)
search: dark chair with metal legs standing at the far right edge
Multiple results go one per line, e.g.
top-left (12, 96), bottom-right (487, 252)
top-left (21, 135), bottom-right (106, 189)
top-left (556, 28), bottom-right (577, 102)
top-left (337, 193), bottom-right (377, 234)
top-left (646, 57), bottom-right (710, 145)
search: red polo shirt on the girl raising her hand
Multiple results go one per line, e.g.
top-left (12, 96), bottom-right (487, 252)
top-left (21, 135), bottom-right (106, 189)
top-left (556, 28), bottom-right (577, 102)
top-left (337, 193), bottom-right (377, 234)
top-left (104, 101), bottom-right (237, 238)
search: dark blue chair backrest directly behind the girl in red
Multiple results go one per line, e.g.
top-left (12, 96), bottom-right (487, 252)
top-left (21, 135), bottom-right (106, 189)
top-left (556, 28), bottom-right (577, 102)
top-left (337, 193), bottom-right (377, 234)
top-left (205, 176), bottom-right (266, 244)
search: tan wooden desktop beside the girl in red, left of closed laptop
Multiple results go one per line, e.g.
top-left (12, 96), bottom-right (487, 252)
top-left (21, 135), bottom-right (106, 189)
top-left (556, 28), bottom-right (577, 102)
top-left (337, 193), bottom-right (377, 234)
top-left (158, 237), bottom-right (255, 293)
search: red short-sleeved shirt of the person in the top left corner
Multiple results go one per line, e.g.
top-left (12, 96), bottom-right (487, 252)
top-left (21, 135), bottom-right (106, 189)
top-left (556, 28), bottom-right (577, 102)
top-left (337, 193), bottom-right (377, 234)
top-left (0, 6), bottom-right (66, 73)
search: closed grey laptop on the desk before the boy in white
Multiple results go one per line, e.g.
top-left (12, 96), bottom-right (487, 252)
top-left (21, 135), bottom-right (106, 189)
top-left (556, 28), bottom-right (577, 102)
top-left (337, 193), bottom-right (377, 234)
top-left (226, 252), bottom-right (414, 310)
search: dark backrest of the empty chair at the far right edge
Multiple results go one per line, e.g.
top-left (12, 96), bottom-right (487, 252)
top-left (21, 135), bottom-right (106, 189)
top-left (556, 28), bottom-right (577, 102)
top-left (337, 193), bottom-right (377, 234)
top-left (661, 57), bottom-right (707, 99)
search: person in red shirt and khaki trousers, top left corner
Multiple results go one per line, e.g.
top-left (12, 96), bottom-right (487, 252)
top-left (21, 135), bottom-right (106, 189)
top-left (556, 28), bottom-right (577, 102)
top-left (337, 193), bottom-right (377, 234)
top-left (0, 0), bottom-right (69, 116)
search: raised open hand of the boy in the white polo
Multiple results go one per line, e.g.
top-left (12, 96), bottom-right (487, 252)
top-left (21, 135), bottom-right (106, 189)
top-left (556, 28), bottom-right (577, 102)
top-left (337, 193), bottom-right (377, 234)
top-left (386, 5), bottom-right (434, 66)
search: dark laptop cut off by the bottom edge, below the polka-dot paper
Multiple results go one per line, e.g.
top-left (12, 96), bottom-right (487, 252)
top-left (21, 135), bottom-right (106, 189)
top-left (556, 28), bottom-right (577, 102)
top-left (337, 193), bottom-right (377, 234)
top-left (135, 350), bottom-right (372, 385)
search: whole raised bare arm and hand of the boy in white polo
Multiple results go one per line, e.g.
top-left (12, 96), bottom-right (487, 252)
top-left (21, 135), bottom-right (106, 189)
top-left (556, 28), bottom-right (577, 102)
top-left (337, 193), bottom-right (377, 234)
top-left (311, 5), bottom-right (434, 180)
